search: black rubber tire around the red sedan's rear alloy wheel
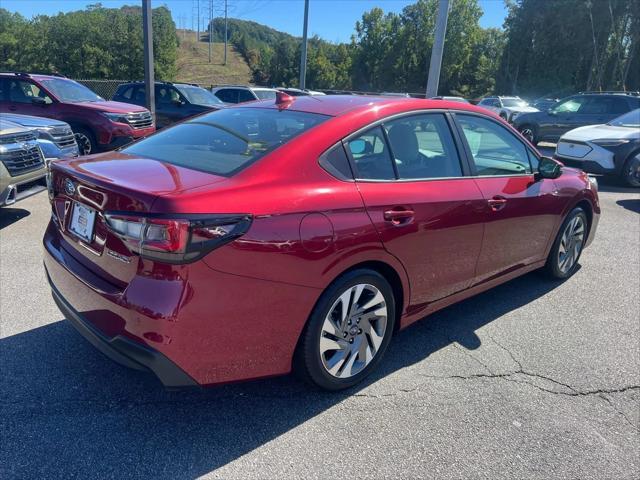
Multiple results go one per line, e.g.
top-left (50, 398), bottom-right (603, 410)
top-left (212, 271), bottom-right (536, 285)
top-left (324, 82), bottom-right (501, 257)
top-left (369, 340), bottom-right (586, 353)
top-left (294, 269), bottom-right (396, 391)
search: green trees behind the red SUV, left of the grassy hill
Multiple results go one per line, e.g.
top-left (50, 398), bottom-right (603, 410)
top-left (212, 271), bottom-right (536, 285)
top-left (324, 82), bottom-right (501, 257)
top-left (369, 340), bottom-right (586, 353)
top-left (0, 4), bottom-right (178, 80)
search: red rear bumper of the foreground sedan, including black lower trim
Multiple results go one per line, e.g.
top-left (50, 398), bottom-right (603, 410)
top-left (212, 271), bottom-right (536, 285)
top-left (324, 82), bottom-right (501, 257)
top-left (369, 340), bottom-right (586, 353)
top-left (43, 222), bottom-right (319, 387)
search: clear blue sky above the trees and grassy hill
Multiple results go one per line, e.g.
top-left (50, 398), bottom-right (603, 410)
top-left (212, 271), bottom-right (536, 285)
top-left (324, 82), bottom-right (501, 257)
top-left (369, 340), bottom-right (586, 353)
top-left (0, 0), bottom-right (507, 42)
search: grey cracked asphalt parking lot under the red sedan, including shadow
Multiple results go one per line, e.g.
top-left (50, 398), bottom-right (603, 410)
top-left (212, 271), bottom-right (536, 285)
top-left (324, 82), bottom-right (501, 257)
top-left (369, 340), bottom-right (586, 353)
top-left (0, 172), bottom-right (640, 479)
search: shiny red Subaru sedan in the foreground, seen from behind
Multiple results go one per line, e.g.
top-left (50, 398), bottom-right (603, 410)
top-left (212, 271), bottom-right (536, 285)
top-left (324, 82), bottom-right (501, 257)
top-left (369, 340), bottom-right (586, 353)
top-left (44, 94), bottom-right (600, 390)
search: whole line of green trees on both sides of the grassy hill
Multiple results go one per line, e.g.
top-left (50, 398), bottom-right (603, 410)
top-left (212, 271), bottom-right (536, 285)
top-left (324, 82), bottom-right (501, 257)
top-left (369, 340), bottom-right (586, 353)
top-left (0, 0), bottom-right (640, 97)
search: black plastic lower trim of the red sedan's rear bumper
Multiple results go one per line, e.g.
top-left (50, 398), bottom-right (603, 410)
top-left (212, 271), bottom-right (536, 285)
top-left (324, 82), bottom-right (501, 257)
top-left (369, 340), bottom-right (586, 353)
top-left (47, 273), bottom-right (198, 388)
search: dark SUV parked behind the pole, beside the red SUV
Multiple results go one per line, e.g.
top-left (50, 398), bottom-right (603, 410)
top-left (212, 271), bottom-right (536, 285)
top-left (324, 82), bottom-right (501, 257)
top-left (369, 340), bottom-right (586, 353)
top-left (113, 82), bottom-right (225, 129)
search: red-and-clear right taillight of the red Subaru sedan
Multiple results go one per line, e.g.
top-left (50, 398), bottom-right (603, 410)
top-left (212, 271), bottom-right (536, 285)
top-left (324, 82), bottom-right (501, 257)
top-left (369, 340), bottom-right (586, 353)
top-left (104, 213), bottom-right (251, 263)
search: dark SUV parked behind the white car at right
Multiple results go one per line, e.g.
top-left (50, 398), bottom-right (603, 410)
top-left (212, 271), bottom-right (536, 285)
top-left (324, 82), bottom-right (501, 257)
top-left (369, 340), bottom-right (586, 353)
top-left (513, 92), bottom-right (640, 145)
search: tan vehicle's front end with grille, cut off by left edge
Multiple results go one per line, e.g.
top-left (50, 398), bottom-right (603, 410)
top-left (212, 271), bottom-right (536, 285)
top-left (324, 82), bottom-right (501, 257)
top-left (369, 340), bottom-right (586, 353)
top-left (0, 118), bottom-right (47, 207)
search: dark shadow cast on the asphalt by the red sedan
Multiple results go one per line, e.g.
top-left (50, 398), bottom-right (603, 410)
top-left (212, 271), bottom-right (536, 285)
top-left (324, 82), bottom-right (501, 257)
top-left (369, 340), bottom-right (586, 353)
top-left (0, 273), bottom-right (561, 479)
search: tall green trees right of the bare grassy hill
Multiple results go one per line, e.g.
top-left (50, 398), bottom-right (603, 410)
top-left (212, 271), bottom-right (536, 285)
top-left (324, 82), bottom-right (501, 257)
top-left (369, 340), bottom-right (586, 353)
top-left (213, 0), bottom-right (640, 97)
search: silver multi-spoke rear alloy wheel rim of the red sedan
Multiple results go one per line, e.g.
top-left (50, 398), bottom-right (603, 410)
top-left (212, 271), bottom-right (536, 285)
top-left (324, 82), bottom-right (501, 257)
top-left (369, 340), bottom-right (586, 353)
top-left (320, 284), bottom-right (387, 378)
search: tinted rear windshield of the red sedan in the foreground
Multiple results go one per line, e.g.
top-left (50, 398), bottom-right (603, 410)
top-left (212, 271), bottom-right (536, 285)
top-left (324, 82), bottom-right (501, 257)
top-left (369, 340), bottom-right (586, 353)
top-left (122, 108), bottom-right (329, 176)
